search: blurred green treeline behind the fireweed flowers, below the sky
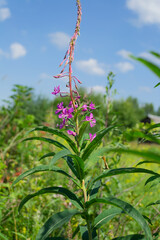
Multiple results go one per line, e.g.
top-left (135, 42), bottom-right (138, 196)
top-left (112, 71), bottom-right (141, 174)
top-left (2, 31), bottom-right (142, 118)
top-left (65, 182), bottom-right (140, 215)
top-left (0, 85), bottom-right (160, 132)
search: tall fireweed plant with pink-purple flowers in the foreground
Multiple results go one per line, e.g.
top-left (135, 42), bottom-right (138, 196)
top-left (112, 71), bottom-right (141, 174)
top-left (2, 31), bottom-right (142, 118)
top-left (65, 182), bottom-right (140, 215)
top-left (13, 0), bottom-right (160, 240)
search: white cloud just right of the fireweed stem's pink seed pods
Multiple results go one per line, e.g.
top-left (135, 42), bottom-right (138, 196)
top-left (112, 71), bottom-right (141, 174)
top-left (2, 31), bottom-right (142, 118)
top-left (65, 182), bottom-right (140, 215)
top-left (76, 58), bottom-right (106, 76)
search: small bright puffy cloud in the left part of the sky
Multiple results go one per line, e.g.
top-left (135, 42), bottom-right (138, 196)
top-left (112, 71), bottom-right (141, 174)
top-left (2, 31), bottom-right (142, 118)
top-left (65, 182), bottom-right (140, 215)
top-left (10, 43), bottom-right (27, 59)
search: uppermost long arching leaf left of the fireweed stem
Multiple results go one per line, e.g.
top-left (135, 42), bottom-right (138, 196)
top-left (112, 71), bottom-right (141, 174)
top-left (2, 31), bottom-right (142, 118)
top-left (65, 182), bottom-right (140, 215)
top-left (29, 126), bottom-right (78, 153)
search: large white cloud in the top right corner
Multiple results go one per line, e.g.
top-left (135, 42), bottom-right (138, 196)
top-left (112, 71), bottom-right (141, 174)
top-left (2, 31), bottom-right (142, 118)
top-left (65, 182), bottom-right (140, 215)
top-left (126, 0), bottom-right (160, 24)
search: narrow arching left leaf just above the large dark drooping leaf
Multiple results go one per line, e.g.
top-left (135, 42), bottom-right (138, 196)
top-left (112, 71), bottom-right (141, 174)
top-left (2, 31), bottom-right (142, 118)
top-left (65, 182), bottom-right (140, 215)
top-left (12, 165), bottom-right (79, 186)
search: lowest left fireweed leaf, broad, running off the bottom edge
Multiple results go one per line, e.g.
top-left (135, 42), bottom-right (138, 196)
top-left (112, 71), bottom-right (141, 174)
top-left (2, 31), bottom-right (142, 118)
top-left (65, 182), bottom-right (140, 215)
top-left (36, 209), bottom-right (80, 240)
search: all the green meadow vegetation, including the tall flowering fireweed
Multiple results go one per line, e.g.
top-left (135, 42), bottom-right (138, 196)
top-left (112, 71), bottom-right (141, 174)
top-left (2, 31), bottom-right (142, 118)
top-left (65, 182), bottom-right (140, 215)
top-left (0, 0), bottom-right (160, 240)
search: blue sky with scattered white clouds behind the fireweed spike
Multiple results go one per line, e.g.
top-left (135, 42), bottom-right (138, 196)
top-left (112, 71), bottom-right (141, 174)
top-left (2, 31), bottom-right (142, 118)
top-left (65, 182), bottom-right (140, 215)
top-left (0, 0), bottom-right (160, 109)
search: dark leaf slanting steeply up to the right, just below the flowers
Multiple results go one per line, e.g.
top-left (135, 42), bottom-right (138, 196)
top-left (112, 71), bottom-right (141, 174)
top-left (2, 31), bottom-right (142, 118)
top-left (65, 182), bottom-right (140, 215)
top-left (82, 126), bottom-right (116, 161)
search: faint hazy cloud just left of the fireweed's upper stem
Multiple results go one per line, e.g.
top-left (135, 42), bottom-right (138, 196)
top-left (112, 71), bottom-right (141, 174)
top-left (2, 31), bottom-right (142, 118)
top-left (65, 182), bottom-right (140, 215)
top-left (49, 32), bottom-right (70, 49)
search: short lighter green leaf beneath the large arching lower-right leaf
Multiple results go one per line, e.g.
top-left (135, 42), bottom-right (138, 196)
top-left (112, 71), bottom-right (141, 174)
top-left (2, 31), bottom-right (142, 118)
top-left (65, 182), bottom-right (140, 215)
top-left (93, 208), bottom-right (123, 228)
